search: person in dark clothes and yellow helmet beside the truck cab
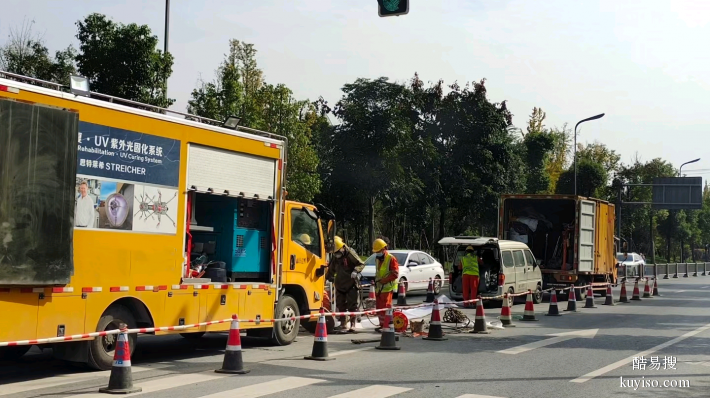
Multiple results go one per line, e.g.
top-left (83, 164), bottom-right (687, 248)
top-left (326, 236), bottom-right (365, 333)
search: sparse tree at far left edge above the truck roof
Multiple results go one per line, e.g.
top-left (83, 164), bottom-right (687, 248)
top-left (0, 21), bottom-right (76, 86)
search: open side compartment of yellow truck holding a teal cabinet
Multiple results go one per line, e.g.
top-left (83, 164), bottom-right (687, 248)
top-left (191, 193), bottom-right (273, 281)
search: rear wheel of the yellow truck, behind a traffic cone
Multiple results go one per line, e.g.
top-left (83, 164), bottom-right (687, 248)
top-left (88, 305), bottom-right (138, 370)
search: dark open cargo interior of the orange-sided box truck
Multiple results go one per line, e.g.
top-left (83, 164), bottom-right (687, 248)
top-left (503, 199), bottom-right (576, 269)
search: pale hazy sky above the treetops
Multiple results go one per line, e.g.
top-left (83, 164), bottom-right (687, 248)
top-left (0, 0), bottom-right (710, 177)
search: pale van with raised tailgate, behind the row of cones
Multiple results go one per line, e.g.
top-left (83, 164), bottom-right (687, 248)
top-left (439, 236), bottom-right (542, 305)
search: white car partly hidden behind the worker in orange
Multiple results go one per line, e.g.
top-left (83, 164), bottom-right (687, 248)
top-left (361, 250), bottom-right (445, 297)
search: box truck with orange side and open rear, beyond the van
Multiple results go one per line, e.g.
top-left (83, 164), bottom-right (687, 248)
top-left (498, 194), bottom-right (617, 297)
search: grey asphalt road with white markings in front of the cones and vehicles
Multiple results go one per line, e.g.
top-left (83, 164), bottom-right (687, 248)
top-left (5, 276), bottom-right (710, 398)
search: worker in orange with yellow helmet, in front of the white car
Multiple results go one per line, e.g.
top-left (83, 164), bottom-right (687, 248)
top-left (372, 239), bottom-right (399, 332)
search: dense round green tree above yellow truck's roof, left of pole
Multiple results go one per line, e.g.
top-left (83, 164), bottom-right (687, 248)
top-left (76, 13), bottom-right (175, 108)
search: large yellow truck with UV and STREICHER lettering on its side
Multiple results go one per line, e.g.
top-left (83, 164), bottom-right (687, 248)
top-left (0, 72), bottom-right (334, 370)
